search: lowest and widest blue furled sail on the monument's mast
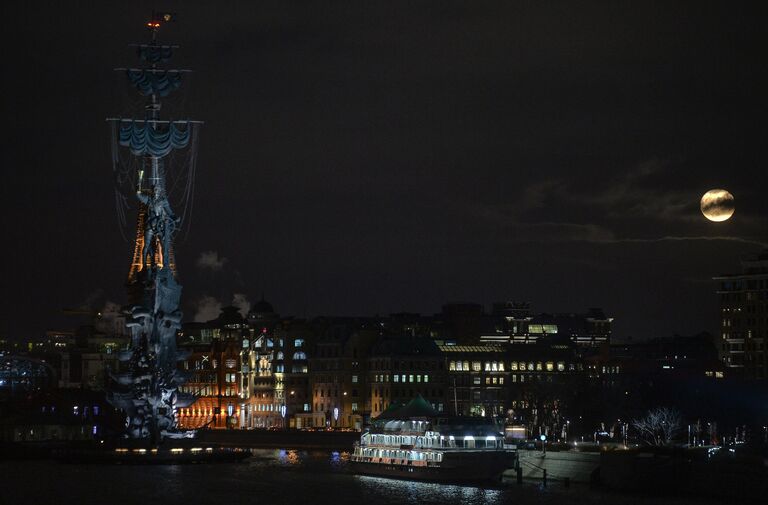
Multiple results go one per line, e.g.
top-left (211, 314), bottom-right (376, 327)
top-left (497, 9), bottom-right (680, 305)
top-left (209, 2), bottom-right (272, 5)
top-left (119, 121), bottom-right (191, 158)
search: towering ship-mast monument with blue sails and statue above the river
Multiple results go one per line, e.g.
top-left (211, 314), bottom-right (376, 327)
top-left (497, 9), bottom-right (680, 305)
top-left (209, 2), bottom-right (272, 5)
top-left (108, 13), bottom-right (202, 445)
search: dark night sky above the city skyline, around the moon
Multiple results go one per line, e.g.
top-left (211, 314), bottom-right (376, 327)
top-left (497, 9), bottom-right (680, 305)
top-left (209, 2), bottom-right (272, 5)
top-left (0, 0), bottom-right (768, 339)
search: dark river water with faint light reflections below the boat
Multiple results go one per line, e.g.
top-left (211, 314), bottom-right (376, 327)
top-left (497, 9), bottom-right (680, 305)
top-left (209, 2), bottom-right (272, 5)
top-left (0, 449), bottom-right (720, 505)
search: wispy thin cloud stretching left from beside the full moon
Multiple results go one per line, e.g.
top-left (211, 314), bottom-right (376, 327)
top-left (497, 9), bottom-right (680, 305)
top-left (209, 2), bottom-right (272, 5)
top-left (467, 158), bottom-right (765, 247)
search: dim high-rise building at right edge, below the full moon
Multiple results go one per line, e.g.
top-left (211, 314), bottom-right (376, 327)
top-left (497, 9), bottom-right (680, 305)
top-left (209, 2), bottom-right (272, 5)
top-left (713, 250), bottom-right (768, 380)
